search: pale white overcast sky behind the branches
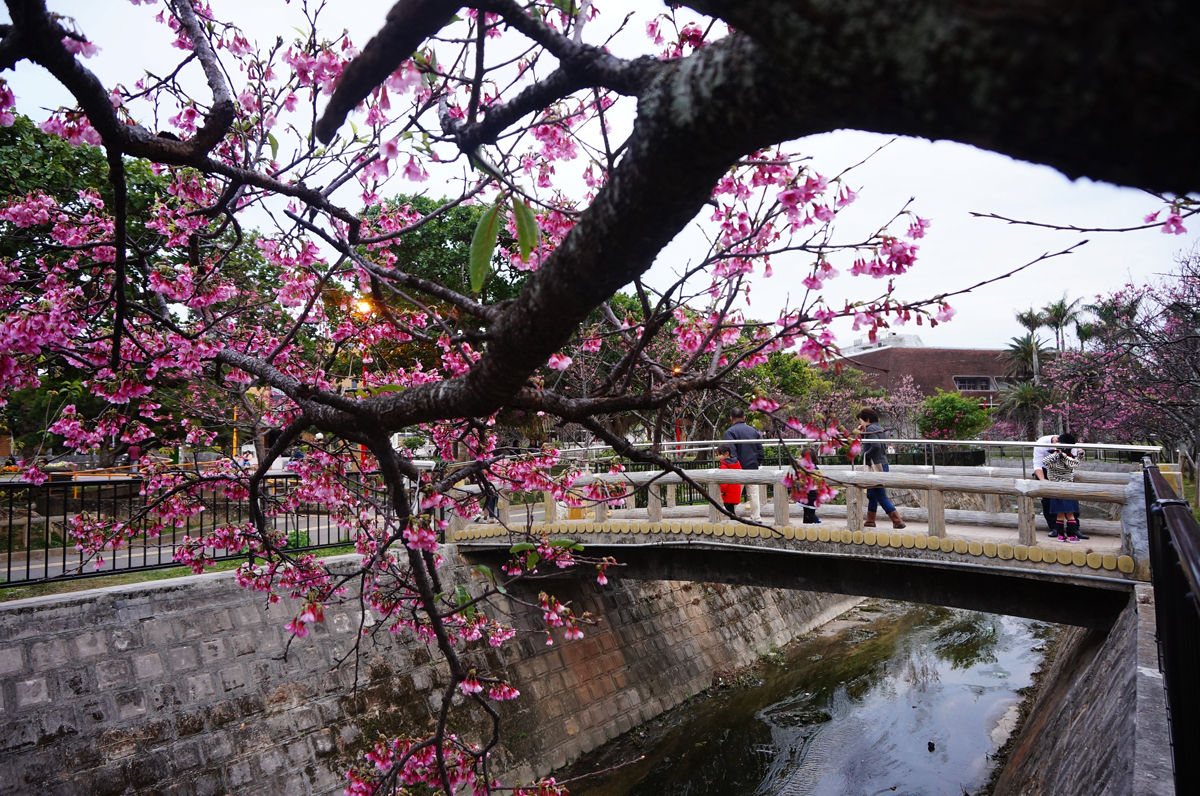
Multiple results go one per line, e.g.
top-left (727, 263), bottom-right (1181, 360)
top-left (0, 0), bottom-right (1200, 347)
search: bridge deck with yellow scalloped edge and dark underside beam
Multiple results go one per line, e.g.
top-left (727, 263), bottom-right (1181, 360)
top-left (449, 520), bottom-right (1139, 630)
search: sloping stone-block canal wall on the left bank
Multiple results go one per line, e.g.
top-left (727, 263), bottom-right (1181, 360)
top-left (0, 549), bottom-right (854, 796)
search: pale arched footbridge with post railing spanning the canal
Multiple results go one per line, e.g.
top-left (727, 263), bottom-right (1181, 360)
top-left (448, 467), bottom-right (1148, 630)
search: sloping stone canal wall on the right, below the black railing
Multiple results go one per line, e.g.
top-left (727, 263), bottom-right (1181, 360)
top-left (992, 586), bottom-right (1175, 796)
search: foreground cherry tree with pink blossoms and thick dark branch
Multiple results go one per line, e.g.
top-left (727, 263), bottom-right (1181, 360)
top-left (0, 0), bottom-right (1200, 794)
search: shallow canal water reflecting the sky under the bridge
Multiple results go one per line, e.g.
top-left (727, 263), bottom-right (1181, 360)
top-left (558, 602), bottom-right (1057, 796)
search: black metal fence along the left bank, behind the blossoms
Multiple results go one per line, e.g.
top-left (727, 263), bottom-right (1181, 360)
top-left (0, 473), bottom-right (373, 585)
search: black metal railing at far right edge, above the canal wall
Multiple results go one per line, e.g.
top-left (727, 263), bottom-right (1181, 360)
top-left (1142, 459), bottom-right (1200, 794)
